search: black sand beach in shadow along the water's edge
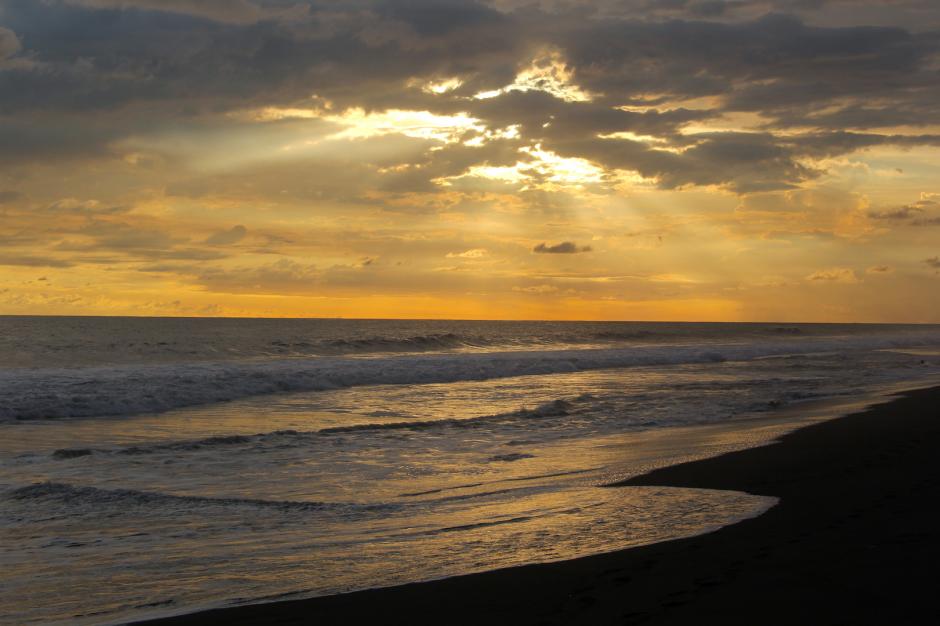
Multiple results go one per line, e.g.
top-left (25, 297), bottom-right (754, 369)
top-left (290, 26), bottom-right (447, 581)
top-left (140, 388), bottom-right (940, 626)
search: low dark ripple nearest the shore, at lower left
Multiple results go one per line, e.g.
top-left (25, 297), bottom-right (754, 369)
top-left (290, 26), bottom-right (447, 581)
top-left (4, 482), bottom-right (401, 513)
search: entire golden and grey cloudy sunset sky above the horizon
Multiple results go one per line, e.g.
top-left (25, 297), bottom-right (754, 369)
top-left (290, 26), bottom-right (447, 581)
top-left (0, 0), bottom-right (940, 322)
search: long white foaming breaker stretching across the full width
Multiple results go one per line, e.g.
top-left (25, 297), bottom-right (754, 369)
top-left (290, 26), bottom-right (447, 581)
top-left (0, 333), bottom-right (940, 420)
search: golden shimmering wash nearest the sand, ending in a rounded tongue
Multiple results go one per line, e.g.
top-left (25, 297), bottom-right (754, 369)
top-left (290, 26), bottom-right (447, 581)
top-left (3, 476), bottom-right (773, 623)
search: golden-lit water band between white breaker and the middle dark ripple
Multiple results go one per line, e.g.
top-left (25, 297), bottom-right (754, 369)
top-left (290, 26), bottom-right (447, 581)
top-left (4, 362), bottom-right (836, 452)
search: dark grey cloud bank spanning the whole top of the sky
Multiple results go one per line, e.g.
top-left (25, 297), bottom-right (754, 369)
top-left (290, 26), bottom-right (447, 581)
top-left (0, 0), bottom-right (940, 193)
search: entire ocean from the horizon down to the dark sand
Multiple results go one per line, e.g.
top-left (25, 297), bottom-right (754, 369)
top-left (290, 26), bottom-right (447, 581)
top-left (0, 317), bottom-right (940, 624)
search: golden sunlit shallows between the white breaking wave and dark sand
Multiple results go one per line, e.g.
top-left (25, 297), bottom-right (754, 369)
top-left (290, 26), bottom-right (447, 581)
top-left (0, 355), bottom-right (936, 623)
